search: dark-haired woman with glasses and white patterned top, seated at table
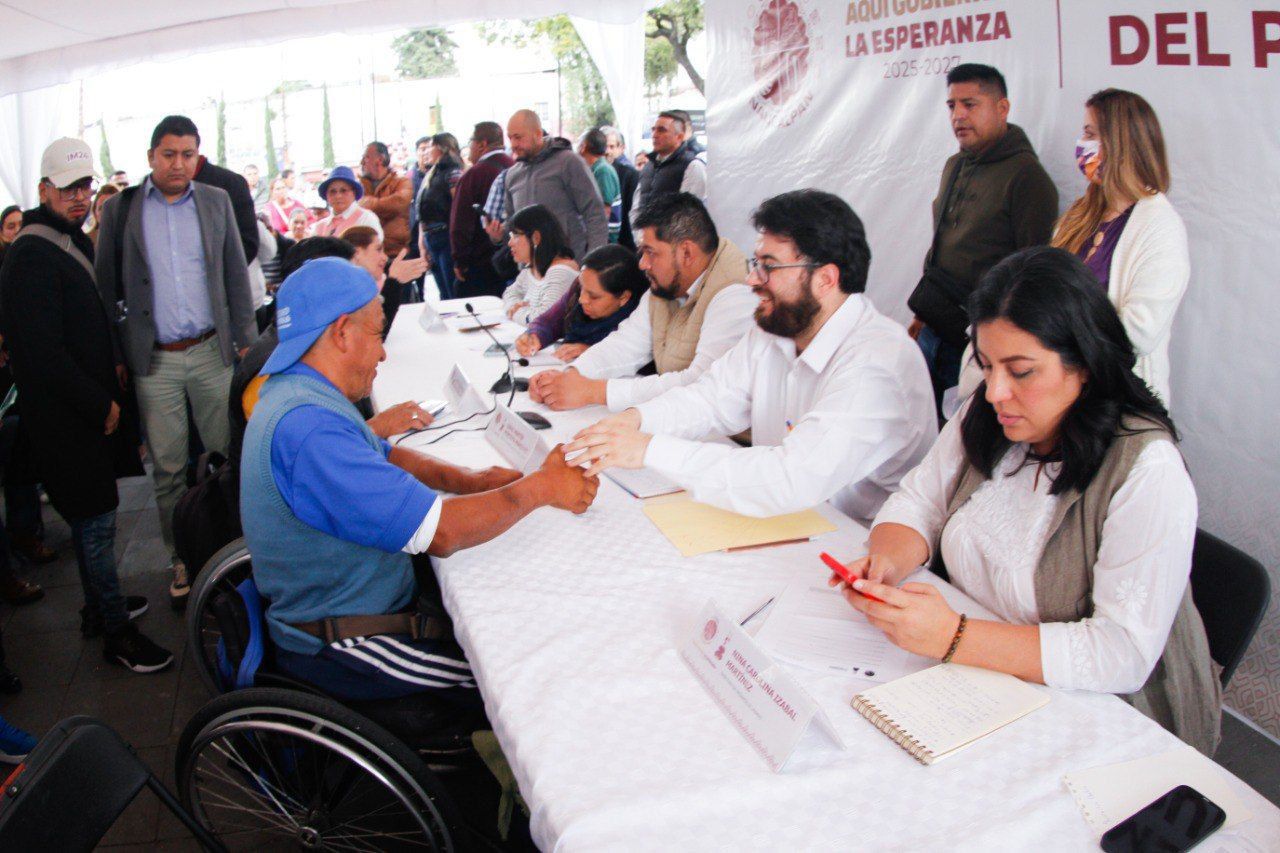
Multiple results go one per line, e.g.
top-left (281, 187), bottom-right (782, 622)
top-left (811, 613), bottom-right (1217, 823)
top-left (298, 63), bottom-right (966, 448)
top-left (502, 205), bottom-right (577, 325)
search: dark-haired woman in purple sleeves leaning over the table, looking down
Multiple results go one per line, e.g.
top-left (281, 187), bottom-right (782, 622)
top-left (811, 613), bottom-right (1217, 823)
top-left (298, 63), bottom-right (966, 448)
top-left (516, 245), bottom-right (649, 361)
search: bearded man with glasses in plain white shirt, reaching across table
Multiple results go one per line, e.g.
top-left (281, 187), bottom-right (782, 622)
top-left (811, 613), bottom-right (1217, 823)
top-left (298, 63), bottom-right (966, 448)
top-left (564, 190), bottom-right (938, 520)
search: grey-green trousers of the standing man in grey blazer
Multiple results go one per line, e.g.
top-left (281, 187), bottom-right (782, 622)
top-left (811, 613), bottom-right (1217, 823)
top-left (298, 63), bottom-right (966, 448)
top-left (134, 336), bottom-right (232, 560)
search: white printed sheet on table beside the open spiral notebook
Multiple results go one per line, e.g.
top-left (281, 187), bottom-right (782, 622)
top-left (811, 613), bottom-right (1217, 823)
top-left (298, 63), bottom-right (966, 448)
top-left (755, 581), bottom-right (918, 683)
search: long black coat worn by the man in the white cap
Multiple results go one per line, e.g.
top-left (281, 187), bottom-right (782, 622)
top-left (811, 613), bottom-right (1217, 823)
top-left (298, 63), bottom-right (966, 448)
top-left (0, 207), bottom-right (142, 520)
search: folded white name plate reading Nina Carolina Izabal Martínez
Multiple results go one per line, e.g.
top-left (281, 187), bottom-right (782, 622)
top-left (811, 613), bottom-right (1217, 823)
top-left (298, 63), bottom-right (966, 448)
top-left (680, 601), bottom-right (845, 772)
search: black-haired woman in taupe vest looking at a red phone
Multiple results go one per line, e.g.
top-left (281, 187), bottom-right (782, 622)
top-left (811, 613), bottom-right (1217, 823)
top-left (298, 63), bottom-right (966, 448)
top-left (832, 247), bottom-right (1221, 754)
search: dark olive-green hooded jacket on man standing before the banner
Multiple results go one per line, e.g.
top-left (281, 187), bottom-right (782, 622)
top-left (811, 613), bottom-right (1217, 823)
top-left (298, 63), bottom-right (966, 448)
top-left (924, 124), bottom-right (1057, 291)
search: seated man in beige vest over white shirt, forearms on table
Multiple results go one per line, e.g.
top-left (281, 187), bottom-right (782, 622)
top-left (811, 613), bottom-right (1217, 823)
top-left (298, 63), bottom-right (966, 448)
top-left (529, 192), bottom-right (758, 411)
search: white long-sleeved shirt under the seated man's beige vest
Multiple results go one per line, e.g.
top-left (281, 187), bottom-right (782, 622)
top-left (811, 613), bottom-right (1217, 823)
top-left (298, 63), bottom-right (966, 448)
top-left (573, 272), bottom-right (760, 407)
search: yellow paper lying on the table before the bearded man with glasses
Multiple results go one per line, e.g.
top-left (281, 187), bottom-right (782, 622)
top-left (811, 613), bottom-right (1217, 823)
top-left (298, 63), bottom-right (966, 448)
top-left (644, 497), bottom-right (836, 557)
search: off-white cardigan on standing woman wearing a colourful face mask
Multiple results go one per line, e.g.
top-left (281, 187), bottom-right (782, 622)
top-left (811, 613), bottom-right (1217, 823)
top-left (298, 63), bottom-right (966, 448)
top-left (956, 192), bottom-right (1192, 407)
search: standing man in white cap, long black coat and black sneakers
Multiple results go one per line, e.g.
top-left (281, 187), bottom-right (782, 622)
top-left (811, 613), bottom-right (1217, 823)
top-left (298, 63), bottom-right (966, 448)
top-left (0, 138), bottom-right (173, 672)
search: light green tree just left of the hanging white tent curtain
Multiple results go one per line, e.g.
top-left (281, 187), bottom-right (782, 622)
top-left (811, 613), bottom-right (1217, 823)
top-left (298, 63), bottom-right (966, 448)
top-left (479, 15), bottom-right (614, 131)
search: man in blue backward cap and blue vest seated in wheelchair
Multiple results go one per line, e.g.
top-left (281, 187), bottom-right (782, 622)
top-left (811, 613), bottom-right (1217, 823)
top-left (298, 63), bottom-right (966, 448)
top-left (241, 257), bottom-right (598, 707)
